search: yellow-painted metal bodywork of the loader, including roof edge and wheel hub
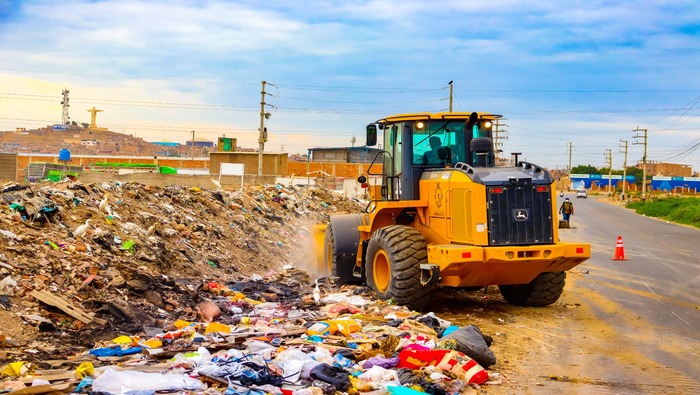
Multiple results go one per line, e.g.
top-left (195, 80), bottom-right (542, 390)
top-left (315, 113), bottom-right (591, 292)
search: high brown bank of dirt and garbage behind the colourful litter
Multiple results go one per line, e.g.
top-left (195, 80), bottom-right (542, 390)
top-left (0, 182), bottom-right (362, 346)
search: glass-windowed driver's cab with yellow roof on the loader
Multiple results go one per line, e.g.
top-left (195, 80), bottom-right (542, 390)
top-left (367, 112), bottom-right (500, 200)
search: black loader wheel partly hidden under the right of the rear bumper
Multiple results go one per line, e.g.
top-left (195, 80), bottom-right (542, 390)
top-left (498, 272), bottom-right (566, 307)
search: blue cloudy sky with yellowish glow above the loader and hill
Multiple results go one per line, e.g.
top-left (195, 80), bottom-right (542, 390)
top-left (0, 0), bottom-right (700, 171)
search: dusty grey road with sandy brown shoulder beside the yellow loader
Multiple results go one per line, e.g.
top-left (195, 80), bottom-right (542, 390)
top-left (436, 194), bottom-right (700, 394)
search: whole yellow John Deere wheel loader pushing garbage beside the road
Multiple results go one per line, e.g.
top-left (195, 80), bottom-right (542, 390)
top-left (316, 112), bottom-right (590, 309)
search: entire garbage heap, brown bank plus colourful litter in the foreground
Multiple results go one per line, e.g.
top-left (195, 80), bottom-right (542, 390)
top-left (0, 182), bottom-right (501, 395)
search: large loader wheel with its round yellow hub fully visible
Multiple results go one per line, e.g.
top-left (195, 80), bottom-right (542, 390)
top-left (366, 225), bottom-right (432, 309)
